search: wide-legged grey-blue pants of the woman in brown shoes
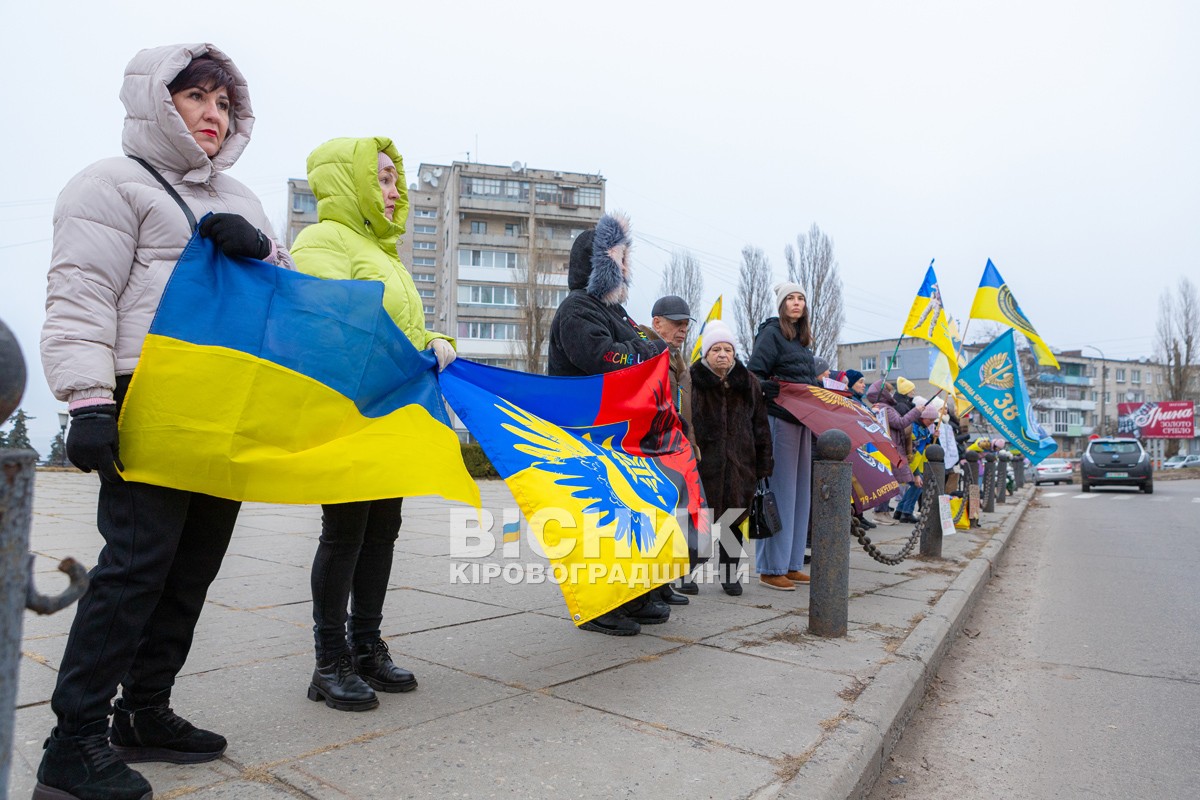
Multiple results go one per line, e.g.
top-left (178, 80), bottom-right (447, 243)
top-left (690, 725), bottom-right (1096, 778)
top-left (755, 416), bottom-right (812, 575)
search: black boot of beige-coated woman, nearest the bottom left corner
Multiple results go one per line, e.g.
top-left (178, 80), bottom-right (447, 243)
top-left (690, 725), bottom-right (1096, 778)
top-left (34, 720), bottom-right (154, 800)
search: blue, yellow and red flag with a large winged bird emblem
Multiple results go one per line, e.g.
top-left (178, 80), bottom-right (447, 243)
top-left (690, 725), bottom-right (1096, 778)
top-left (440, 354), bottom-right (708, 625)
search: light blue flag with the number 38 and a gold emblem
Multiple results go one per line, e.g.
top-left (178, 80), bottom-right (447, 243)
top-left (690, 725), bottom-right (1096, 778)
top-left (954, 330), bottom-right (1058, 464)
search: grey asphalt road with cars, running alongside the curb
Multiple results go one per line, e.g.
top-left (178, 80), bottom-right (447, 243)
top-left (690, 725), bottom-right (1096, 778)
top-left (870, 480), bottom-right (1200, 800)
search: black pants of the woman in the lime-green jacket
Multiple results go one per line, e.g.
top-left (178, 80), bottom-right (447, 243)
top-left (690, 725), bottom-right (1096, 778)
top-left (312, 498), bottom-right (403, 663)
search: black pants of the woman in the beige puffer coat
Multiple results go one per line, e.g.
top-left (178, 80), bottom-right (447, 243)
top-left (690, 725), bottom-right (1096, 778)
top-left (50, 477), bottom-right (241, 735)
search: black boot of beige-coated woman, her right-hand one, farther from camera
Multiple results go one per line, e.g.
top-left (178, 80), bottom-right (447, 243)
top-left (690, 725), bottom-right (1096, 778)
top-left (108, 691), bottom-right (228, 764)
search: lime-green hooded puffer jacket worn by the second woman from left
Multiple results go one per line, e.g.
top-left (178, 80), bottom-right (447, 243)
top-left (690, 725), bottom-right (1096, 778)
top-left (292, 137), bottom-right (454, 350)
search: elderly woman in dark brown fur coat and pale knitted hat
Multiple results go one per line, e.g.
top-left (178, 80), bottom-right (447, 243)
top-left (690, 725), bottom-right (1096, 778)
top-left (691, 320), bottom-right (774, 596)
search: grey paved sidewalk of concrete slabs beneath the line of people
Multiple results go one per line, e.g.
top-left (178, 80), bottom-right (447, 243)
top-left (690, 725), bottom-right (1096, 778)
top-left (8, 473), bottom-right (1032, 800)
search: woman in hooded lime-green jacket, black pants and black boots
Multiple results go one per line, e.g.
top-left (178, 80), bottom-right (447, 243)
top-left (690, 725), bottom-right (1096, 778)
top-left (292, 137), bottom-right (455, 711)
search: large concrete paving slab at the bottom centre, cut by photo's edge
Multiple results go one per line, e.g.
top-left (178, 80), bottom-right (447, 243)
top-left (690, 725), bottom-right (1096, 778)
top-left (271, 694), bottom-right (773, 800)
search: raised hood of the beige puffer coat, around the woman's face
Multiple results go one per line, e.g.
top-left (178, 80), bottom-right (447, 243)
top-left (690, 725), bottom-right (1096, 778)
top-left (121, 44), bottom-right (254, 184)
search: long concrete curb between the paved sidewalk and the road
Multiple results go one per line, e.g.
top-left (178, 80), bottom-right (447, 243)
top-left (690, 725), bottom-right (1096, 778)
top-left (774, 485), bottom-right (1037, 800)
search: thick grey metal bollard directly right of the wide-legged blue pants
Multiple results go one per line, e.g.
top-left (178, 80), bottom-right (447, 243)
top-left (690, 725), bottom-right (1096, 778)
top-left (809, 431), bottom-right (851, 637)
